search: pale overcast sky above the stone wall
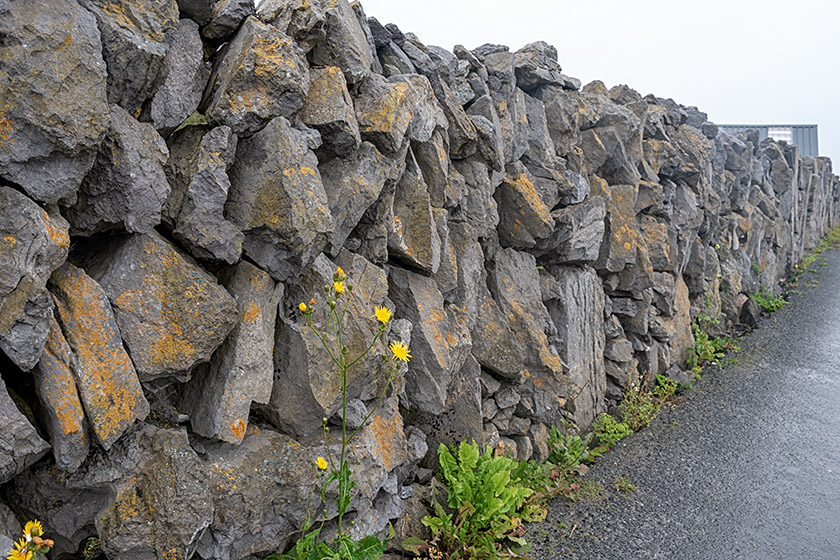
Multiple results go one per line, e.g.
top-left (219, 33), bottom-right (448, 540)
top-left (361, 0), bottom-right (840, 165)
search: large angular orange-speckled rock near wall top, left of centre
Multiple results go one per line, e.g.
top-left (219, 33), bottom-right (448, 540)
top-left (202, 17), bottom-right (309, 134)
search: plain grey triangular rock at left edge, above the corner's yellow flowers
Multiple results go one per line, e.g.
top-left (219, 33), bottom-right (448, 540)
top-left (0, 379), bottom-right (50, 484)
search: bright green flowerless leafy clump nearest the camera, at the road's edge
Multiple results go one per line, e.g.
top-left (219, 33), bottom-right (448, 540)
top-left (403, 442), bottom-right (534, 558)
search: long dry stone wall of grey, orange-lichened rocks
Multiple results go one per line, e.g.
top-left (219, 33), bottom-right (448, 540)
top-left (0, 0), bottom-right (840, 560)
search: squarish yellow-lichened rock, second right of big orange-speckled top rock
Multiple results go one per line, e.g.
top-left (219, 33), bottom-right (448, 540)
top-left (356, 74), bottom-right (416, 155)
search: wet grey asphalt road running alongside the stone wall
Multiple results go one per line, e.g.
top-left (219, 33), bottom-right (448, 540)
top-left (526, 250), bottom-right (840, 560)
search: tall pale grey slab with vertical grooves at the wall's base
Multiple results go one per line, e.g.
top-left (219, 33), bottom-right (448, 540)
top-left (540, 266), bottom-right (612, 426)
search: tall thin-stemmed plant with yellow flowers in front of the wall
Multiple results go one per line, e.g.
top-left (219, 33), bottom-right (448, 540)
top-left (266, 267), bottom-right (411, 560)
